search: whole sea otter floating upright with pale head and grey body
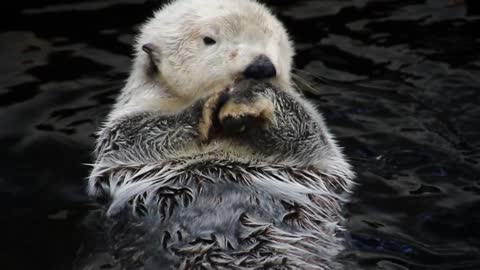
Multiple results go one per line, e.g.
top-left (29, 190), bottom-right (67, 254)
top-left (88, 0), bottom-right (353, 269)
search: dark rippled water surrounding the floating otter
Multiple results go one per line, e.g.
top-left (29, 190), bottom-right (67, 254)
top-left (0, 0), bottom-right (480, 270)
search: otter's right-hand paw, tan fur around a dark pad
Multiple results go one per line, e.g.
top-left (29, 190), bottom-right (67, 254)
top-left (218, 95), bottom-right (273, 134)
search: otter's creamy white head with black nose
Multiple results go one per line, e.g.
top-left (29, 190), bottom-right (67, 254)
top-left (135, 0), bottom-right (294, 103)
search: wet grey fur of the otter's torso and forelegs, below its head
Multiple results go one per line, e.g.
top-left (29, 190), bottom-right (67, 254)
top-left (89, 81), bottom-right (353, 270)
